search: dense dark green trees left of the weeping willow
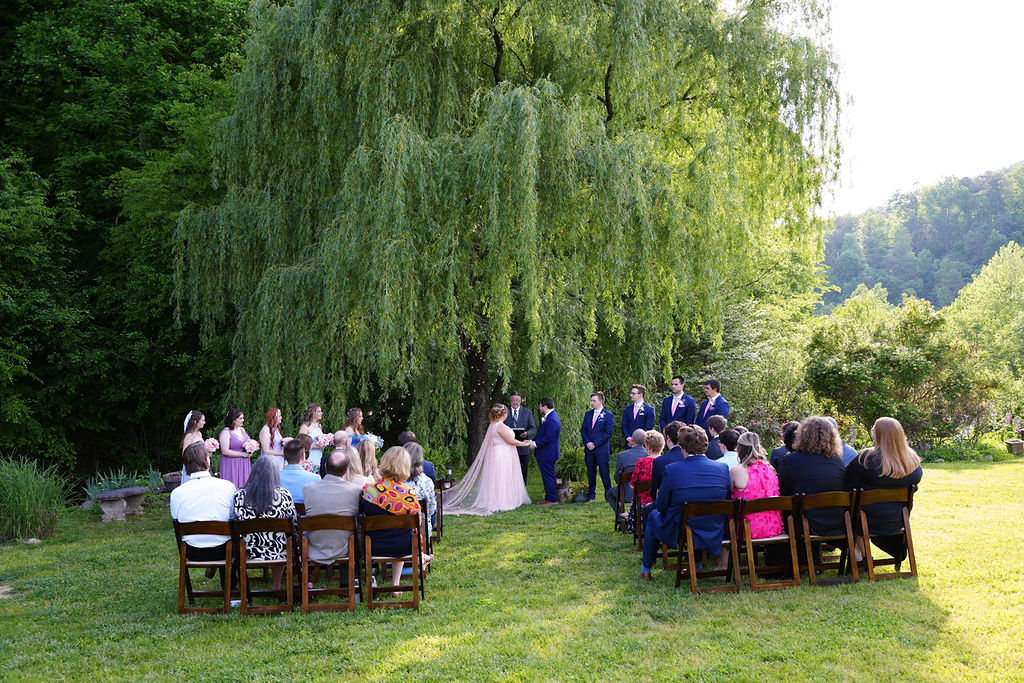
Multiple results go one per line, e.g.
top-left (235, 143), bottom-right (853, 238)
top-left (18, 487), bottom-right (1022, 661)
top-left (0, 0), bottom-right (246, 469)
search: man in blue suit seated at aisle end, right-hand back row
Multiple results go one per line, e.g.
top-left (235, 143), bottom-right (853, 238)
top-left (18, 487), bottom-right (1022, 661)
top-left (640, 427), bottom-right (729, 581)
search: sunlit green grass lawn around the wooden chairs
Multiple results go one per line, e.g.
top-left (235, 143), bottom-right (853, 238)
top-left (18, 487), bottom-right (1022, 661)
top-left (0, 462), bottom-right (1024, 681)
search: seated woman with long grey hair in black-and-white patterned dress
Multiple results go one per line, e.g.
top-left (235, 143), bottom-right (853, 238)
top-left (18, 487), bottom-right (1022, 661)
top-left (232, 454), bottom-right (296, 591)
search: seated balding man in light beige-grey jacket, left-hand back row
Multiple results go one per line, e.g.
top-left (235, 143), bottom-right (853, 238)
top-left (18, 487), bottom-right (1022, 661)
top-left (302, 446), bottom-right (362, 564)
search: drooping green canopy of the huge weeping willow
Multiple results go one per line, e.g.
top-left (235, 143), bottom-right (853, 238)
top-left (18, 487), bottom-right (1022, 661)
top-left (179, 0), bottom-right (839, 464)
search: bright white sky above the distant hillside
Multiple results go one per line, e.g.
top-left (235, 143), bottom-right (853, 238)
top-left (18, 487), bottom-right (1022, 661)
top-left (825, 0), bottom-right (1024, 214)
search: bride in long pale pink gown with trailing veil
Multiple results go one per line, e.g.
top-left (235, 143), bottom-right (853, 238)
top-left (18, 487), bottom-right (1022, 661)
top-left (444, 403), bottom-right (531, 515)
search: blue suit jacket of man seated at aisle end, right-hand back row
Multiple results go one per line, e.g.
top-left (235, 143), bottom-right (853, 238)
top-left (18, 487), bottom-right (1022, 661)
top-left (647, 455), bottom-right (730, 555)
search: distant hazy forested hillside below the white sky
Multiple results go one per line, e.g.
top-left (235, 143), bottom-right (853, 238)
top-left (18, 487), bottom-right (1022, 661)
top-left (824, 163), bottom-right (1024, 308)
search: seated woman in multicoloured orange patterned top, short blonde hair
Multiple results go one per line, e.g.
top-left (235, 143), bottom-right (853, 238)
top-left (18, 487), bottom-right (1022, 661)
top-left (359, 445), bottom-right (433, 586)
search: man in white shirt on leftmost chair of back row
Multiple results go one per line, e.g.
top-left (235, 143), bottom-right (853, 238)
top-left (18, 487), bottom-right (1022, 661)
top-left (171, 440), bottom-right (236, 586)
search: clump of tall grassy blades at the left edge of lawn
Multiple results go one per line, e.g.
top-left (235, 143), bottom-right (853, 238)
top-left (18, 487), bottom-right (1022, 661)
top-left (0, 457), bottom-right (68, 540)
